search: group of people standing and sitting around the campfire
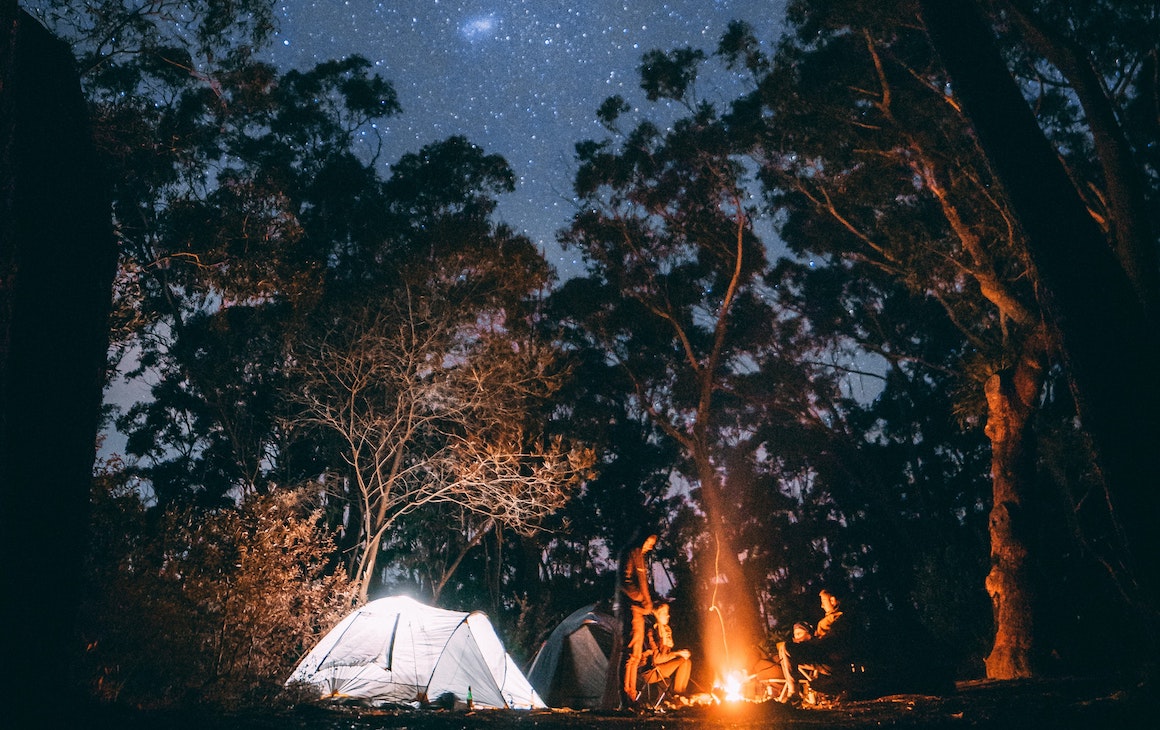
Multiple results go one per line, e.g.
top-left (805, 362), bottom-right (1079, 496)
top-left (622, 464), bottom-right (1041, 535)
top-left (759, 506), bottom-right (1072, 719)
top-left (615, 526), bottom-right (853, 707)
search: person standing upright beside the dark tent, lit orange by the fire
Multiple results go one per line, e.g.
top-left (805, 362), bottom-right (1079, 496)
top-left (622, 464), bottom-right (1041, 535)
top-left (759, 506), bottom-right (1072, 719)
top-left (616, 533), bottom-right (657, 707)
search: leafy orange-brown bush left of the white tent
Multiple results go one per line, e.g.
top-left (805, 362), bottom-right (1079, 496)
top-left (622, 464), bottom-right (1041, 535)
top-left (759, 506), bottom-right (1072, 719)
top-left (81, 457), bottom-right (351, 708)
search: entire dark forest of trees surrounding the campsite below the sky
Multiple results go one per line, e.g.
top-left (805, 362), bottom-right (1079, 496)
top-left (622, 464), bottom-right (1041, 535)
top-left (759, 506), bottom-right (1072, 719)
top-left (0, 0), bottom-right (1160, 709)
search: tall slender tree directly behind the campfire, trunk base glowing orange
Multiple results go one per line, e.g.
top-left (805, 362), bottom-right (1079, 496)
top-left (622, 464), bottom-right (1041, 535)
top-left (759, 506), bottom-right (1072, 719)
top-left (553, 49), bottom-right (853, 668)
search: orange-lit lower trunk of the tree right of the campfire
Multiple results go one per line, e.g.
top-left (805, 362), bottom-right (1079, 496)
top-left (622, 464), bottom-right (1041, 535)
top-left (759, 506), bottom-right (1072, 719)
top-left (986, 337), bottom-right (1045, 679)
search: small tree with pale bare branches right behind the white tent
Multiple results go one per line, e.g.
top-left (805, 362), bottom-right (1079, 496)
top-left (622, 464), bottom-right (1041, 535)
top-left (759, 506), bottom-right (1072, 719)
top-left (287, 288), bottom-right (592, 600)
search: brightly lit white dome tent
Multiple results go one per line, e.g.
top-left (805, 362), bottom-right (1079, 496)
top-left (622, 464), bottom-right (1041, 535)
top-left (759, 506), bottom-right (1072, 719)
top-left (287, 595), bottom-right (544, 709)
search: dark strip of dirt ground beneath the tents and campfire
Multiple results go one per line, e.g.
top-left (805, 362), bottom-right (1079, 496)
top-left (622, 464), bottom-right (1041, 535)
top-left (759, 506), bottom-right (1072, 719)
top-left (88, 679), bottom-right (1146, 730)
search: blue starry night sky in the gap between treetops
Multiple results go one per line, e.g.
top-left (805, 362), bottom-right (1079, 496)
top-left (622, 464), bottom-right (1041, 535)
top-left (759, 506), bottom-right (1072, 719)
top-left (265, 0), bottom-right (785, 276)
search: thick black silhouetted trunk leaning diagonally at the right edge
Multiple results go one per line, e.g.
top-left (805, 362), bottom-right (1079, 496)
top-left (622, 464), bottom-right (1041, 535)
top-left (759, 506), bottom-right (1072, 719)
top-left (920, 0), bottom-right (1160, 643)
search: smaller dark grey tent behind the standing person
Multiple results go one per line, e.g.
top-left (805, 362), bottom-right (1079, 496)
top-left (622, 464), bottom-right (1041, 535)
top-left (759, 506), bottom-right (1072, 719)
top-left (528, 603), bottom-right (619, 709)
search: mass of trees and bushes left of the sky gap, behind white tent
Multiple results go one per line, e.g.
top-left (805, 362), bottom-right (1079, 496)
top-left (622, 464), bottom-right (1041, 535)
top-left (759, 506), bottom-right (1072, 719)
top-left (28, 2), bottom-right (590, 701)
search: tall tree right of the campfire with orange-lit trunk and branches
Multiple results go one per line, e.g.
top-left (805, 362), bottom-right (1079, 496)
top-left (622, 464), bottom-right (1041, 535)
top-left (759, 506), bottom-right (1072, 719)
top-left (722, 2), bottom-right (1155, 677)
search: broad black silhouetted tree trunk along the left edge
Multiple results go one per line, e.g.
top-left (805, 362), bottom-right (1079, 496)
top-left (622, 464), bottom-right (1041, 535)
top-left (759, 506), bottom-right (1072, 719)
top-left (0, 2), bottom-right (116, 725)
